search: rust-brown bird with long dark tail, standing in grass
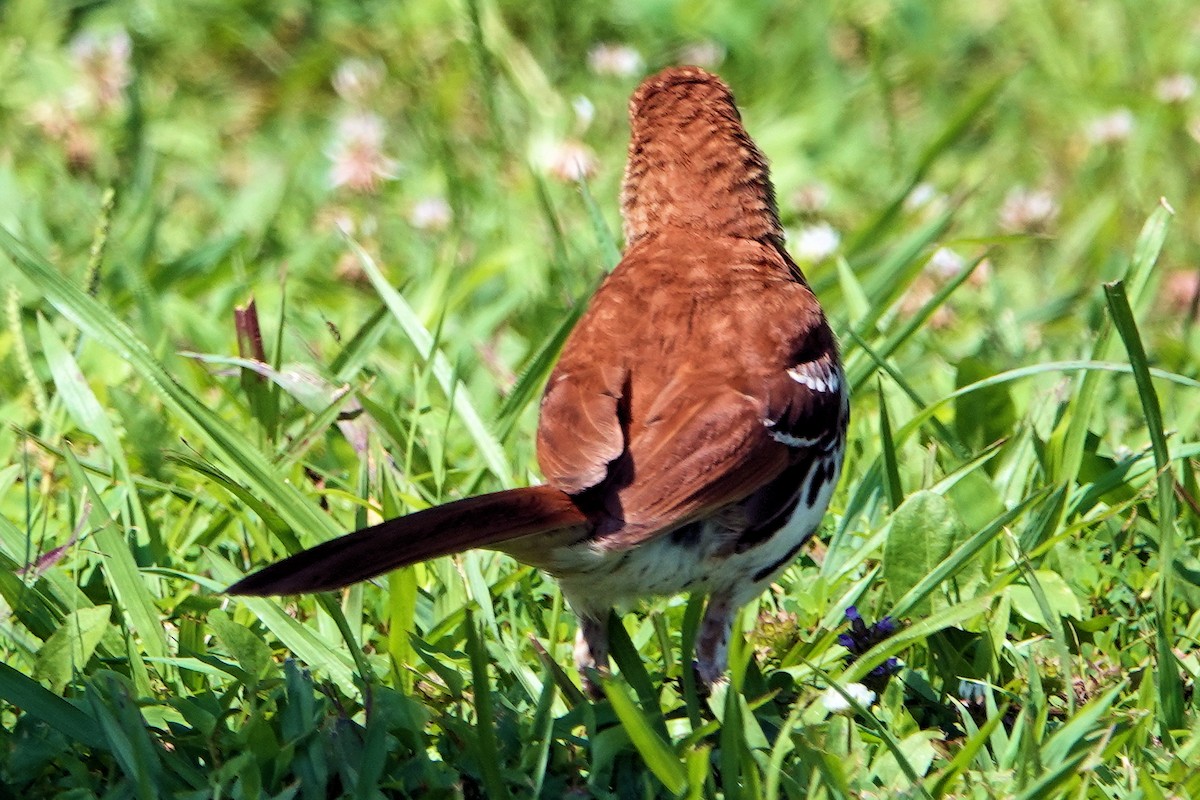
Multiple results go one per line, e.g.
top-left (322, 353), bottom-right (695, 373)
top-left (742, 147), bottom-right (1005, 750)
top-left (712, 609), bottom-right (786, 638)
top-left (228, 66), bottom-right (850, 697)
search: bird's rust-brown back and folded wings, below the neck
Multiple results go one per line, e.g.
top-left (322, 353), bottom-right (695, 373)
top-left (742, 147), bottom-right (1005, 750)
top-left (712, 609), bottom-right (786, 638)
top-left (538, 236), bottom-right (845, 548)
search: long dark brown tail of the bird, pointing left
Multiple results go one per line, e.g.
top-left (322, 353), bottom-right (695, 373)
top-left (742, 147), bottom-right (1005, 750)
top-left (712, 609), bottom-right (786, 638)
top-left (228, 486), bottom-right (588, 595)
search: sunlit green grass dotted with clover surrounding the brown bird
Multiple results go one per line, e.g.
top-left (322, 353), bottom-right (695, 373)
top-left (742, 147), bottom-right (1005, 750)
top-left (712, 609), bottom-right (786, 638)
top-left (0, 0), bottom-right (1200, 800)
